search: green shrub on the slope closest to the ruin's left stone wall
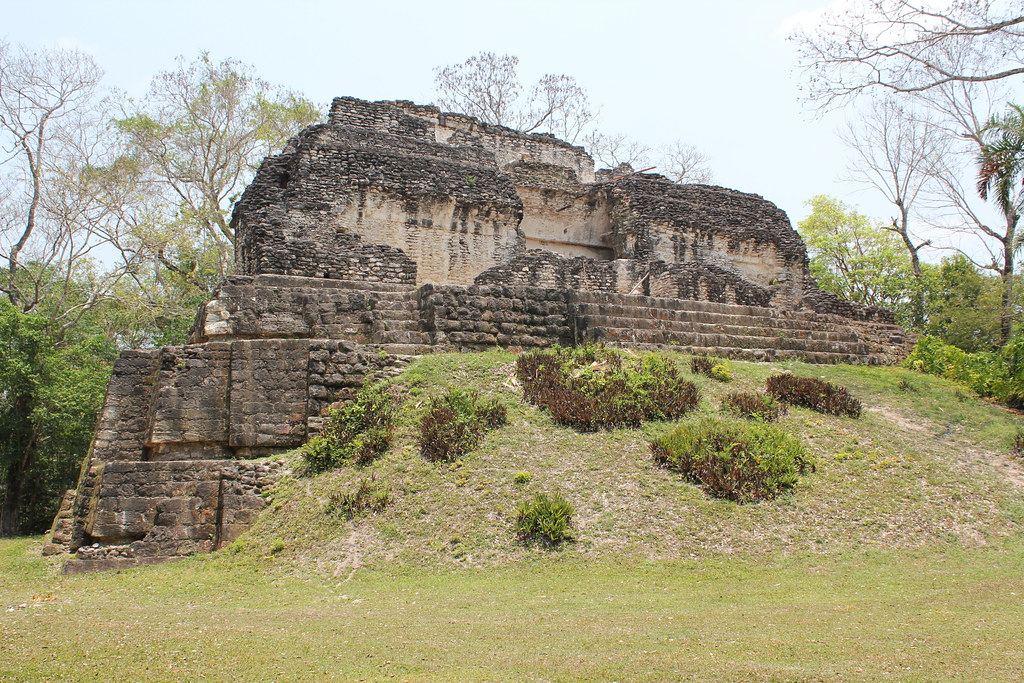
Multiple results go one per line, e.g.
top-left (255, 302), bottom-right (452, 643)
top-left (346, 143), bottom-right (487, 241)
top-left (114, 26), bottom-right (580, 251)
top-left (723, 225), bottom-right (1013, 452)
top-left (302, 382), bottom-right (398, 473)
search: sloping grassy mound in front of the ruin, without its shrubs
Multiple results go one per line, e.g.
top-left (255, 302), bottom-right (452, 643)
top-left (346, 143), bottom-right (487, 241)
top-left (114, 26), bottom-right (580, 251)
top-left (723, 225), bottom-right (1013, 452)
top-left (228, 351), bottom-right (1024, 577)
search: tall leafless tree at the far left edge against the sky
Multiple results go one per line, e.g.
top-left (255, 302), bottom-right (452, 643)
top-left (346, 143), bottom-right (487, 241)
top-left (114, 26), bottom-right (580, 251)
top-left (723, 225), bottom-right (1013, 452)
top-left (0, 44), bottom-right (144, 334)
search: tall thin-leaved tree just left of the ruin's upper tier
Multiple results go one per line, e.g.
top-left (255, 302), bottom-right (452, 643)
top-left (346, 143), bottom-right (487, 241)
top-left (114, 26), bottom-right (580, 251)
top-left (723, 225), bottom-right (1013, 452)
top-left (117, 53), bottom-right (319, 282)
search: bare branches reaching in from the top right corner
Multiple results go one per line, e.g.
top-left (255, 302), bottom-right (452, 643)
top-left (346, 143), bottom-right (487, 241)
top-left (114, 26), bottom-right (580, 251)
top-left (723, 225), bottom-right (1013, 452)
top-left (791, 0), bottom-right (1024, 106)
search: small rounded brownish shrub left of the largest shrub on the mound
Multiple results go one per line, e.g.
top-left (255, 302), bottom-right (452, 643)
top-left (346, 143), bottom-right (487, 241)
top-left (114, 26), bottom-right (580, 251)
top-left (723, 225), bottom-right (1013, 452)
top-left (420, 389), bottom-right (506, 461)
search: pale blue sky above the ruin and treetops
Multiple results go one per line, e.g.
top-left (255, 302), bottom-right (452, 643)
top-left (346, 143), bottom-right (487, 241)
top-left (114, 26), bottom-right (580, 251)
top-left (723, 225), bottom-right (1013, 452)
top-left (0, 0), bottom-right (983, 231)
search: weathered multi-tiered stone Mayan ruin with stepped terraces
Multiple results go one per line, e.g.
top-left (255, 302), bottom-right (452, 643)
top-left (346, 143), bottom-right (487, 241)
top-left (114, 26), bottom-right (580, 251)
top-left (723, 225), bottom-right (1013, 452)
top-left (46, 97), bottom-right (911, 572)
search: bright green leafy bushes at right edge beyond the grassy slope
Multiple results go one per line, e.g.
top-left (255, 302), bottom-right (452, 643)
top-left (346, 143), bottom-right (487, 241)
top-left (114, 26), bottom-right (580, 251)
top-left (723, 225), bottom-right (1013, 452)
top-left (904, 337), bottom-right (1024, 408)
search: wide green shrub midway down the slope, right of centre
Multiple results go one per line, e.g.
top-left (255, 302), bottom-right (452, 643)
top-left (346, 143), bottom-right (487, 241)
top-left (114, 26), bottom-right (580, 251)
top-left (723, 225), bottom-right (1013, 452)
top-left (650, 418), bottom-right (814, 503)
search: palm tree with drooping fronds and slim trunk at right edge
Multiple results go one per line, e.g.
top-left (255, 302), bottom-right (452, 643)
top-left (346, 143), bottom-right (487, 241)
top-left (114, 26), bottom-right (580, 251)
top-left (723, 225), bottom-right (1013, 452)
top-left (978, 104), bottom-right (1024, 344)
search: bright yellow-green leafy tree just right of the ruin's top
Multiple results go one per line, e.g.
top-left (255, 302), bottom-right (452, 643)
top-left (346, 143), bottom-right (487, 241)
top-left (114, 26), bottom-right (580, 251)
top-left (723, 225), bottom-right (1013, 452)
top-left (797, 195), bottom-right (915, 324)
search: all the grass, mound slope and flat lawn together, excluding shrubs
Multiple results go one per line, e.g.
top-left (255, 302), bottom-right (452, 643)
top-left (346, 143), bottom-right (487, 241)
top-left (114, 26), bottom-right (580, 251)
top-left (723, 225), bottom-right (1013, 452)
top-left (6, 351), bottom-right (1024, 681)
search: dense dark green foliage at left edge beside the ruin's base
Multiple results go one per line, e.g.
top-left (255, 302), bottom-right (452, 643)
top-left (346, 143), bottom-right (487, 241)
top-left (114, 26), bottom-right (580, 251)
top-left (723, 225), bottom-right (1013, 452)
top-left (0, 301), bottom-right (116, 535)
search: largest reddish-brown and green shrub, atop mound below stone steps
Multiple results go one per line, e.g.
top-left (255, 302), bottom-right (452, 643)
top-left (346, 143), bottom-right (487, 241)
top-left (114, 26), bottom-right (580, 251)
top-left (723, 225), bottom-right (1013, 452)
top-left (516, 344), bottom-right (699, 431)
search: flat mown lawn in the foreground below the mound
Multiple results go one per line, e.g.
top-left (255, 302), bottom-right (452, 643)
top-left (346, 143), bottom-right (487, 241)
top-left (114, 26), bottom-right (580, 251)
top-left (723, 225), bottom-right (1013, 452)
top-left (0, 539), bottom-right (1024, 681)
